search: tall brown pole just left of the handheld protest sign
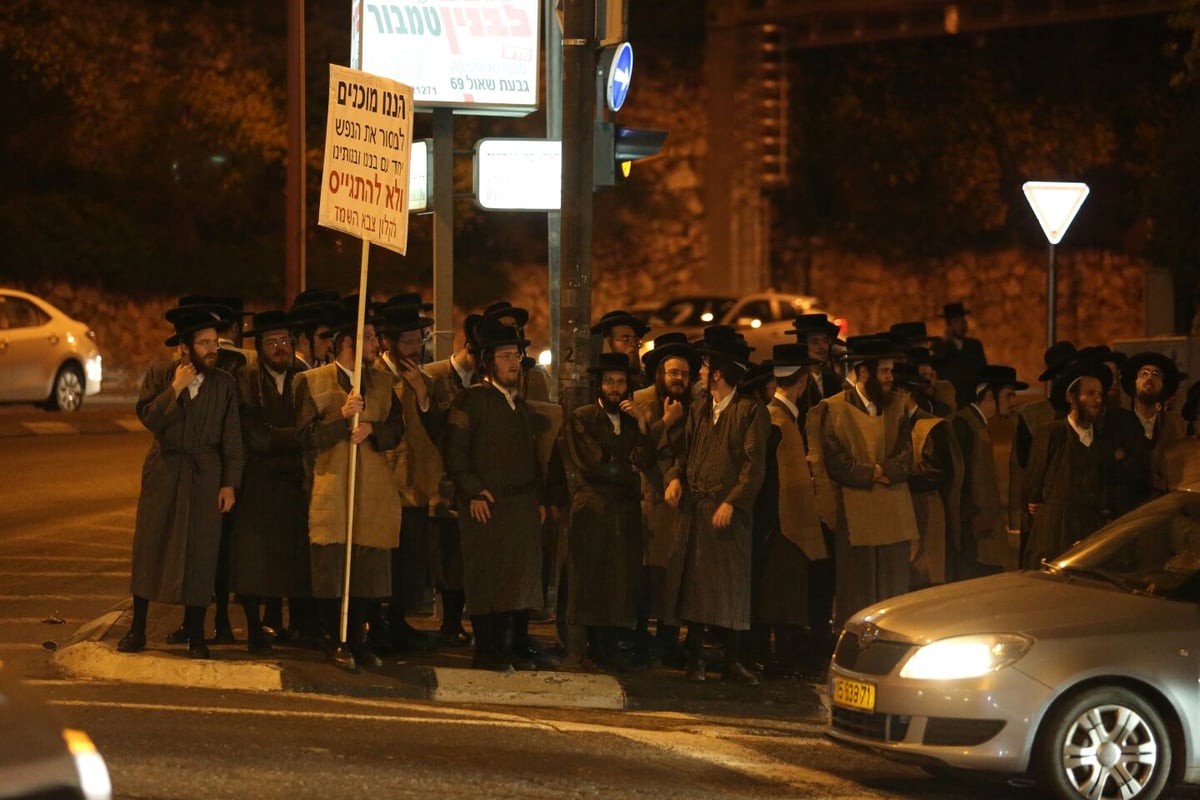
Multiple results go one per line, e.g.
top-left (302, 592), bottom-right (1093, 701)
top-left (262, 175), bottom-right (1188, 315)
top-left (281, 0), bottom-right (307, 303)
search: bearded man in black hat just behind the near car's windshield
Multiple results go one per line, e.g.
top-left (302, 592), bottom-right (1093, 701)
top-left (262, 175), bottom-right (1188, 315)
top-left (1021, 361), bottom-right (1112, 570)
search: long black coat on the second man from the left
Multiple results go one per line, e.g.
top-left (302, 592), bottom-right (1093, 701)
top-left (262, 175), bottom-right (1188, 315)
top-left (229, 361), bottom-right (312, 597)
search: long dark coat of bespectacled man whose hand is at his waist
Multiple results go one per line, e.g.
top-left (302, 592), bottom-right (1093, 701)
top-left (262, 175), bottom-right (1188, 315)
top-left (442, 383), bottom-right (544, 614)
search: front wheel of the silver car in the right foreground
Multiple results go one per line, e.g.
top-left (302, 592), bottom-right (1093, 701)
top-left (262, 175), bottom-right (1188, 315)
top-left (1034, 686), bottom-right (1171, 800)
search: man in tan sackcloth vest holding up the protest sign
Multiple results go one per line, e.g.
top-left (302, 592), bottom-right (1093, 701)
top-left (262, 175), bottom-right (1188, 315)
top-left (295, 309), bottom-right (404, 670)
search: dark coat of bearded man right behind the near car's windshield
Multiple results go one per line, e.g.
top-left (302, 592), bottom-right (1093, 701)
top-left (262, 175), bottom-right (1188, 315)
top-left (1021, 420), bottom-right (1112, 570)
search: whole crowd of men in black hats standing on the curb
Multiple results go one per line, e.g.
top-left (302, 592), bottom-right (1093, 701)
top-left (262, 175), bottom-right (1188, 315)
top-left (118, 297), bottom-right (1200, 686)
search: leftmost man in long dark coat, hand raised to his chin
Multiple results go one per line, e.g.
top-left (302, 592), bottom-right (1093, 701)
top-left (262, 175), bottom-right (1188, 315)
top-left (116, 306), bottom-right (244, 658)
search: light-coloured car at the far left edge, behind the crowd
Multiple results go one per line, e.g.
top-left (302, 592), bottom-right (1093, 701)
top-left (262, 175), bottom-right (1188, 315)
top-left (0, 289), bottom-right (103, 411)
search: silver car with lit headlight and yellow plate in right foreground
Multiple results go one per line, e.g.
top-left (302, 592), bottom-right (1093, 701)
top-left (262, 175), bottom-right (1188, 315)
top-left (829, 485), bottom-right (1200, 800)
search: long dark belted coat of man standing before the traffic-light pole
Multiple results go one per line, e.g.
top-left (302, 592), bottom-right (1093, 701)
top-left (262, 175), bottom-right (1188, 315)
top-left (566, 403), bottom-right (654, 627)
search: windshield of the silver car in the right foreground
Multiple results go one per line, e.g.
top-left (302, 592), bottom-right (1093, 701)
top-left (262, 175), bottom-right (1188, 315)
top-left (1049, 492), bottom-right (1200, 601)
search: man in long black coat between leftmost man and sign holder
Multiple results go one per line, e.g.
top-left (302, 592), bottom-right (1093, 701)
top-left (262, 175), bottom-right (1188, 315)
top-left (229, 309), bottom-right (316, 654)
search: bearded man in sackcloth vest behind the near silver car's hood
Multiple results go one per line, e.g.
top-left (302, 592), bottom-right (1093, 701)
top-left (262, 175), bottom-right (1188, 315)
top-left (809, 333), bottom-right (918, 626)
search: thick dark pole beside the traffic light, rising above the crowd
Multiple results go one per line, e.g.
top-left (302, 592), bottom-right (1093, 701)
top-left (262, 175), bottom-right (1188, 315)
top-left (554, 0), bottom-right (596, 414)
